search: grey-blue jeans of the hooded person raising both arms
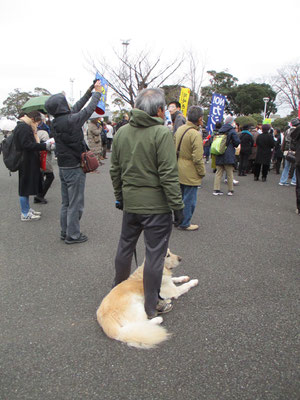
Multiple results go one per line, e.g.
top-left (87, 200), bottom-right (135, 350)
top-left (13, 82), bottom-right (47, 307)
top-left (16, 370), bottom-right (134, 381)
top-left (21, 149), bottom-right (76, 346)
top-left (59, 167), bottom-right (86, 239)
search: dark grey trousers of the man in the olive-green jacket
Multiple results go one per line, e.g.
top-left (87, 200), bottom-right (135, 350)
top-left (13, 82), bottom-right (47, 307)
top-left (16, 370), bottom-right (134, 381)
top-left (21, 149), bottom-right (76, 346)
top-left (113, 212), bottom-right (172, 316)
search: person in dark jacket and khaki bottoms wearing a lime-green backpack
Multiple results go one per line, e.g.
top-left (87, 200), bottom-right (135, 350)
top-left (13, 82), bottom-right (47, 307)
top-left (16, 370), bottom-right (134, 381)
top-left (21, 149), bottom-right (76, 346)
top-left (213, 115), bottom-right (240, 196)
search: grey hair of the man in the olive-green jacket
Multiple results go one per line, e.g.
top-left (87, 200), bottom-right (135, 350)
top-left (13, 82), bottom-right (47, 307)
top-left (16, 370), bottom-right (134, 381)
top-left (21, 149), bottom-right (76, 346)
top-left (134, 89), bottom-right (166, 117)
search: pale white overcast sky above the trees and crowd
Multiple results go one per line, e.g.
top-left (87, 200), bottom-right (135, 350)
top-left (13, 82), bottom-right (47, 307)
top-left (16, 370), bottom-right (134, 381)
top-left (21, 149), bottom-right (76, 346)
top-left (0, 0), bottom-right (300, 115)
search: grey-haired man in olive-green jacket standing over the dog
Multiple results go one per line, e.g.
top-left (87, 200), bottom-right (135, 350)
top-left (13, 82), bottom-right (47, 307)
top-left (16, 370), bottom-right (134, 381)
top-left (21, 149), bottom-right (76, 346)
top-left (110, 89), bottom-right (183, 318)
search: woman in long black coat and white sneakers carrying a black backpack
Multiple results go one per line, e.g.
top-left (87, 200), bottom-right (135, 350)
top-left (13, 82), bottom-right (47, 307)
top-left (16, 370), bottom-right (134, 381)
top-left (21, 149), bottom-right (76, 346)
top-left (14, 111), bottom-right (47, 221)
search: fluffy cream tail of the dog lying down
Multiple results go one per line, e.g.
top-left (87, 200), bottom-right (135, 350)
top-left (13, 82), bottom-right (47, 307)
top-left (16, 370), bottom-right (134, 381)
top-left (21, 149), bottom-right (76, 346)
top-left (116, 320), bottom-right (170, 349)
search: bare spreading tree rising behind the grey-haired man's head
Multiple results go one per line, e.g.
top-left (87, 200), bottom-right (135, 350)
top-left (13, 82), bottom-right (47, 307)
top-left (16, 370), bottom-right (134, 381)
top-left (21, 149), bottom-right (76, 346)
top-left (87, 46), bottom-right (183, 107)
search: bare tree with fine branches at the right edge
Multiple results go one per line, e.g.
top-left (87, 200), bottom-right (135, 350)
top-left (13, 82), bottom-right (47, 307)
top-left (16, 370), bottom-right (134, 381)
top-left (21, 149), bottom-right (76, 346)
top-left (272, 63), bottom-right (300, 111)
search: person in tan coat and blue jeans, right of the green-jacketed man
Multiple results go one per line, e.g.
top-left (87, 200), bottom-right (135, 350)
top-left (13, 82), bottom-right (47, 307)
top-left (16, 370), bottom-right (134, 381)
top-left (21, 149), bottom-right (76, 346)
top-left (174, 106), bottom-right (205, 231)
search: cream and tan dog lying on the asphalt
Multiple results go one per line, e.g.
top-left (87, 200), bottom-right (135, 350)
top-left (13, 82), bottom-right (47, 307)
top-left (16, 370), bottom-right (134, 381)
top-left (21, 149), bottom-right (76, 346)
top-left (97, 250), bottom-right (198, 348)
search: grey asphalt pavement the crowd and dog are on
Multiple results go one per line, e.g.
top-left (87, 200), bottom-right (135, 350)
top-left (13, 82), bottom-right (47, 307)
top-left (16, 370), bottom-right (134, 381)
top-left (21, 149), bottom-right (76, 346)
top-left (0, 146), bottom-right (300, 400)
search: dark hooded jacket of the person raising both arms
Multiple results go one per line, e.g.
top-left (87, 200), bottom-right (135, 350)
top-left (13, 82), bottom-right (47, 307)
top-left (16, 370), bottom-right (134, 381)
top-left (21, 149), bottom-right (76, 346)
top-left (45, 90), bottom-right (101, 168)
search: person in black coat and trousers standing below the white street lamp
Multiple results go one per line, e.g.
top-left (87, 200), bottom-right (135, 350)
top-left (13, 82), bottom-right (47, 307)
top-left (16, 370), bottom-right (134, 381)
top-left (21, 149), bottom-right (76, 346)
top-left (254, 124), bottom-right (275, 182)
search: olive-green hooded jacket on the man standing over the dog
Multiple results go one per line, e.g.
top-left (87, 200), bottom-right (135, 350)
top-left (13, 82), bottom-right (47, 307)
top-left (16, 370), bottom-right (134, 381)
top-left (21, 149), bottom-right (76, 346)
top-left (110, 109), bottom-right (184, 214)
